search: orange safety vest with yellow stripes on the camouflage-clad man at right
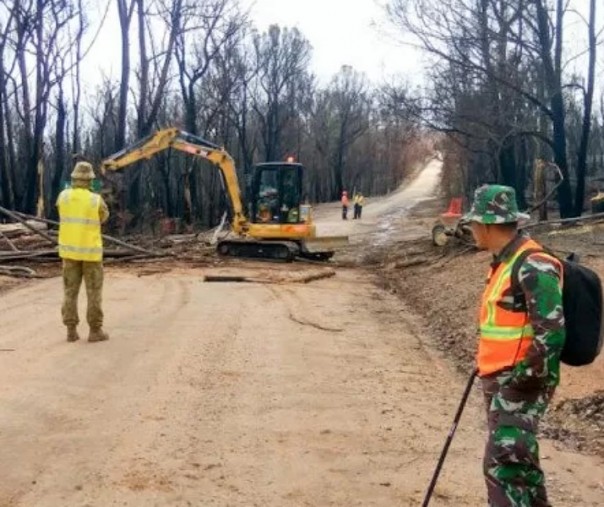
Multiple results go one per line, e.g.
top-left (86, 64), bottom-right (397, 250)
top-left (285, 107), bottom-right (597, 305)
top-left (477, 239), bottom-right (562, 376)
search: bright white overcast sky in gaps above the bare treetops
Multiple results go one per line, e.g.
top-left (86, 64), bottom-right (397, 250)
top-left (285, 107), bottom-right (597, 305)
top-left (84, 0), bottom-right (421, 86)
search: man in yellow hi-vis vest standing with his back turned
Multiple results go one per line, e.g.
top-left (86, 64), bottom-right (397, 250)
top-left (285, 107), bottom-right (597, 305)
top-left (57, 162), bottom-right (109, 342)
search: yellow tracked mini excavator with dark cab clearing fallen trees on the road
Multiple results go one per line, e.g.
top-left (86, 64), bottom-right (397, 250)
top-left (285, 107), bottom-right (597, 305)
top-left (101, 128), bottom-right (348, 261)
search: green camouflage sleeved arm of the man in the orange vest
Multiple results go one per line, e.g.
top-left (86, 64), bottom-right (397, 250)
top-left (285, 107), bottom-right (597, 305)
top-left (511, 253), bottom-right (565, 388)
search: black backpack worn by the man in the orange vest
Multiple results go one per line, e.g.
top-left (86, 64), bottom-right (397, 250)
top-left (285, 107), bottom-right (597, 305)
top-left (512, 249), bottom-right (602, 366)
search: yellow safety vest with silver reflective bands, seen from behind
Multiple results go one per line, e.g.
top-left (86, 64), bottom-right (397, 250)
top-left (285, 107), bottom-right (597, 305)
top-left (57, 188), bottom-right (103, 262)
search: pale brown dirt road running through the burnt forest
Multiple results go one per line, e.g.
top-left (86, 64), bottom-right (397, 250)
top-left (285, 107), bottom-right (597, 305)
top-left (0, 166), bottom-right (603, 507)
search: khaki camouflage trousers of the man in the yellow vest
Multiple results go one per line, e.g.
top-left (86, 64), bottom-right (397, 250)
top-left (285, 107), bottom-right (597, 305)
top-left (61, 259), bottom-right (103, 329)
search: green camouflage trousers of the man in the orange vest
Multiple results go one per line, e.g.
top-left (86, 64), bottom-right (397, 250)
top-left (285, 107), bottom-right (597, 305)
top-left (482, 371), bottom-right (555, 507)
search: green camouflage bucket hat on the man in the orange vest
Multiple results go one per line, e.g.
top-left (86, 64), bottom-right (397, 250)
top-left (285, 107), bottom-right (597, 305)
top-left (464, 185), bottom-right (530, 225)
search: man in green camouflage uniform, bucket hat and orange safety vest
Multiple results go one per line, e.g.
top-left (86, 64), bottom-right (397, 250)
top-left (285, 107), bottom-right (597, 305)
top-left (465, 185), bottom-right (565, 507)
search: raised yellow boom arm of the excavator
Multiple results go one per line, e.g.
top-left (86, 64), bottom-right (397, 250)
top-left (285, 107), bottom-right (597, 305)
top-left (101, 128), bottom-right (249, 234)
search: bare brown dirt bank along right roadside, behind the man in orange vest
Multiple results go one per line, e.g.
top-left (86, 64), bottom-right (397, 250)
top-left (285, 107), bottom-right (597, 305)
top-left (368, 228), bottom-right (604, 456)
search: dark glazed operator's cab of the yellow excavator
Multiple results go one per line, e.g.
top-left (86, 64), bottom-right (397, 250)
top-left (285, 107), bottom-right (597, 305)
top-left (249, 162), bottom-right (304, 224)
